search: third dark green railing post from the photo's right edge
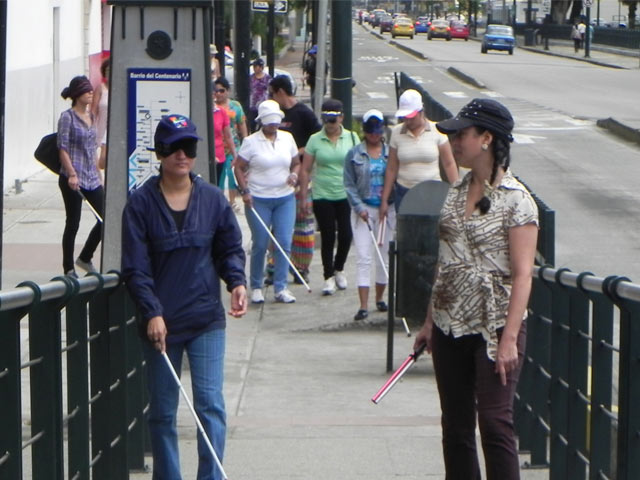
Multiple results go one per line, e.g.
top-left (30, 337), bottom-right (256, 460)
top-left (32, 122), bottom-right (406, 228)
top-left (549, 268), bottom-right (569, 480)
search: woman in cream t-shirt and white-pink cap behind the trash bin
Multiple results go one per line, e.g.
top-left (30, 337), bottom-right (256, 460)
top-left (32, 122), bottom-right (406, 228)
top-left (380, 90), bottom-right (458, 216)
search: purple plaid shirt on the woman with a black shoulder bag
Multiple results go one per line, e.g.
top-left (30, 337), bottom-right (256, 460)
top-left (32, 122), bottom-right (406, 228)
top-left (58, 108), bottom-right (101, 190)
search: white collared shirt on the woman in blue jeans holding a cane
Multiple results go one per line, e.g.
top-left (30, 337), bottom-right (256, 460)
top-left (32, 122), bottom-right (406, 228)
top-left (238, 130), bottom-right (298, 198)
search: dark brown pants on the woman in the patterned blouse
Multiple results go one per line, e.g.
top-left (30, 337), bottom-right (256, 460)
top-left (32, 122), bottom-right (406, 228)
top-left (432, 322), bottom-right (526, 480)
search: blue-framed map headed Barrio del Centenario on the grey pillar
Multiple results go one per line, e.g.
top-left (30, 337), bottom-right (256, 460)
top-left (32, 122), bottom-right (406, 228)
top-left (127, 68), bottom-right (191, 191)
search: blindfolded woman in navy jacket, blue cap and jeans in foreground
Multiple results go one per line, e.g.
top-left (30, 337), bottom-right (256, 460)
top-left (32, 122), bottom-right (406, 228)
top-left (122, 115), bottom-right (247, 480)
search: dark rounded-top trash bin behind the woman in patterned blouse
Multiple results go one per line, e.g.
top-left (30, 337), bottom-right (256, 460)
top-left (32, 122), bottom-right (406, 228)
top-left (395, 181), bottom-right (449, 326)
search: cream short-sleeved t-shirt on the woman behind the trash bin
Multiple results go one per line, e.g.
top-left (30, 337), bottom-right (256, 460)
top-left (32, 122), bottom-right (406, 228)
top-left (389, 121), bottom-right (449, 188)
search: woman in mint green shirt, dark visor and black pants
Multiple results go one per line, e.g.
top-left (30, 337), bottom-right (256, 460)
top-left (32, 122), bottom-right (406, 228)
top-left (300, 98), bottom-right (360, 295)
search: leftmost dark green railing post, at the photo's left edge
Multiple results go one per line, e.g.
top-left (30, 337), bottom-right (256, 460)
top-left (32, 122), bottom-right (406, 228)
top-left (0, 309), bottom-right (27, 480)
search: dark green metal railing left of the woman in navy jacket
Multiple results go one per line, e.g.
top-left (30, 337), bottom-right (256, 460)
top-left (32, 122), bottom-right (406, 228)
top-left (0, 273), bottom-right (147, 480)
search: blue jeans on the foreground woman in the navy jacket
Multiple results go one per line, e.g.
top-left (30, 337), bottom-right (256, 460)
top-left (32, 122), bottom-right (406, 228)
top-left (143, 329), bottom-right (227, 480)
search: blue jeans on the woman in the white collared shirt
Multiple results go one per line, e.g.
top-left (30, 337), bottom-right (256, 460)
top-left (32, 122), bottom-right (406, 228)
top-left (245, 193), bottom-right (296, 293)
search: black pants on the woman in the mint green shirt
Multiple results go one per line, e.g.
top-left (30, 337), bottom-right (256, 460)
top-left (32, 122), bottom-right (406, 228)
top-left (313, 198), bottom-right (353, 280)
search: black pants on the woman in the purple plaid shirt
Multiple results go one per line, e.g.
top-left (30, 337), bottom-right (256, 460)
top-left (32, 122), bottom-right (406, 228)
top-left (58, 175), bottom-right (104, 273)
